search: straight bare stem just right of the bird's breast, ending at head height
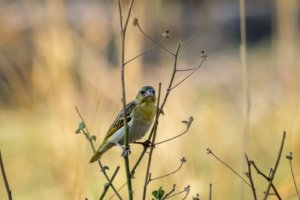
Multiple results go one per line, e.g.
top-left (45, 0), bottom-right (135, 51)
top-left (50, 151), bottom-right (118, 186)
top-left (143, 83), bottom-right (161, 200)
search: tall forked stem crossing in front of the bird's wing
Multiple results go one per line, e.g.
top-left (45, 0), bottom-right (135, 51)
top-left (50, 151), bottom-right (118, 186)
top-left (118, 0), bottom-right (133, 200)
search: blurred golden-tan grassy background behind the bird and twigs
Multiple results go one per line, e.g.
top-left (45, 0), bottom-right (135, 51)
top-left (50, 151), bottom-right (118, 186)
top-left (0, 0), bottom-right (300, 200)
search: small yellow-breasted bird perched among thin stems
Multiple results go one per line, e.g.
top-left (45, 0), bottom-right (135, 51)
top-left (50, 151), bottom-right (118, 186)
top-left (90, 86), bottom-right (156, 163)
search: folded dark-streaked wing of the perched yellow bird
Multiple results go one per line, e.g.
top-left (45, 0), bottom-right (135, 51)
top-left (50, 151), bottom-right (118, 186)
top-left (101, 101), bottom-right (135, 146)
